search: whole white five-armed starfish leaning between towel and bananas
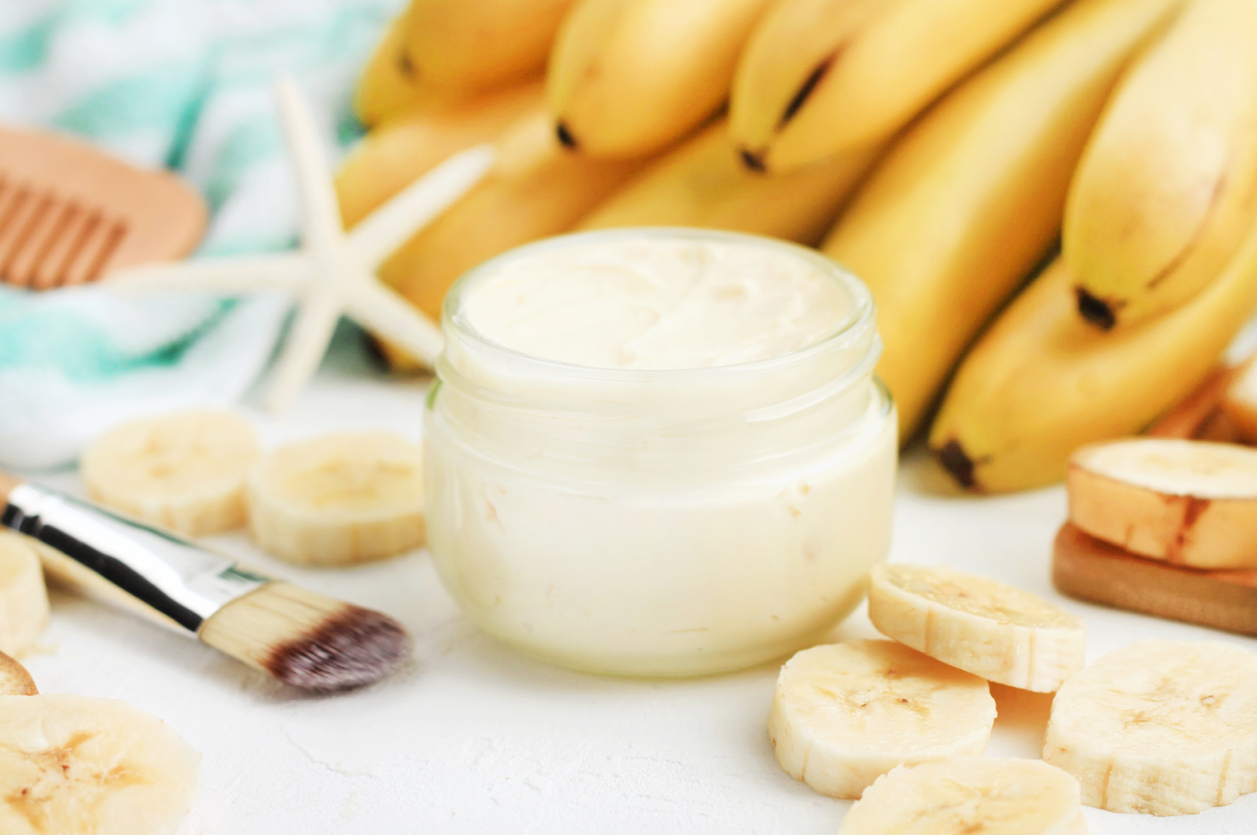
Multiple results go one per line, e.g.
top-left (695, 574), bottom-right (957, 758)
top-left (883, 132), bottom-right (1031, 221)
top-left (106, 78), bottom-right (494, 411)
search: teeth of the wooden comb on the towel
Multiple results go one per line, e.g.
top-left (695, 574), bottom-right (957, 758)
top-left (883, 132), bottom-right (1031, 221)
top-left (0, 175), bottom-right (127, 289)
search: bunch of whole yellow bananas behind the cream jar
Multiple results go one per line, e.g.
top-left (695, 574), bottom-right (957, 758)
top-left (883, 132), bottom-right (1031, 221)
top-left (349, 0), bottom-right (1257, 492)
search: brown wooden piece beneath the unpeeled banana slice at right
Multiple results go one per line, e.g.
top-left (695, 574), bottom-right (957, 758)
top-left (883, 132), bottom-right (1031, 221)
top-left (1052, 522), bottom-right (1257, 635)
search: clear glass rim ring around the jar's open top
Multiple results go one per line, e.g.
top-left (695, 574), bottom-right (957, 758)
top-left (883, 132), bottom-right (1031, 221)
top-left (441, 226), bottom-right (876, 384)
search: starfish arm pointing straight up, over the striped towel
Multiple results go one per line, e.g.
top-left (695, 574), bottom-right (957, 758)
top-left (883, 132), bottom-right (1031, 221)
top-left (275, 75), bottom-right (344, 250)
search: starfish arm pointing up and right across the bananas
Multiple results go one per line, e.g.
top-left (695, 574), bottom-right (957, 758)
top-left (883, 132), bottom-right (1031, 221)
top-left (348, 145), bottom-right (497, 270)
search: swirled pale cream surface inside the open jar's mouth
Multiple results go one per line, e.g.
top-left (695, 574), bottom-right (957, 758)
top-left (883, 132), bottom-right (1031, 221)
top-left (465, 238), bottom-right (852, 370)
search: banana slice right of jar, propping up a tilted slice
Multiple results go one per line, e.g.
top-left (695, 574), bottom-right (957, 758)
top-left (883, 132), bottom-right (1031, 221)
top-left (768, 640), bottom-right (996, 799)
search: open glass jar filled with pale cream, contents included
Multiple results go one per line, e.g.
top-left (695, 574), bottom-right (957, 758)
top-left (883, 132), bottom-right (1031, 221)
top-left (425, 229), bottom-right (897, 675)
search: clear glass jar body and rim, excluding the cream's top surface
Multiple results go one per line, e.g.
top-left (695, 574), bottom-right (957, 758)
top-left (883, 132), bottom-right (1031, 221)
top-left (425, 229), bottom-right (897, 675)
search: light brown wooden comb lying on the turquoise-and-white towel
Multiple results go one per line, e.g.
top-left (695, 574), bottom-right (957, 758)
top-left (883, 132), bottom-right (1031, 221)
top-left (0, 128), bottom-right (206, 290)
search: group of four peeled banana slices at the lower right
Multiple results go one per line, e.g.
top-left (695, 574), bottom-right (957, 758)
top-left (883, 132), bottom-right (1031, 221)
top-left (768, 558), bottom-right (1257, 835)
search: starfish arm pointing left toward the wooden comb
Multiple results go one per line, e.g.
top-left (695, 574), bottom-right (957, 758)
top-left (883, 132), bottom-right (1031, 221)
top-left (102, 253), bottom-right (310, 293)
